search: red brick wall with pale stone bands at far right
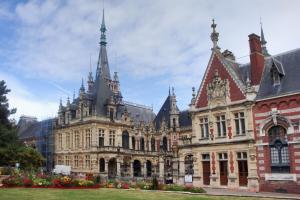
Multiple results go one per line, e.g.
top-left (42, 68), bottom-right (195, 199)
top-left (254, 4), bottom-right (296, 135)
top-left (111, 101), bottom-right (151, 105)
top-left (253, 94), bottom-right (300, 193)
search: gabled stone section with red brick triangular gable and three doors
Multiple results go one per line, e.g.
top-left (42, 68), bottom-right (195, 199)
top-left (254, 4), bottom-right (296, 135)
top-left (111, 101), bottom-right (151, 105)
top-left (178, 20), bottom-right (258, 191)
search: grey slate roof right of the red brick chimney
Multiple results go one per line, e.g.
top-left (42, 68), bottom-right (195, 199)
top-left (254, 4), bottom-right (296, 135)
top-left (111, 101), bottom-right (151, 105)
top-left (257, 48), bottom-right (300, 100)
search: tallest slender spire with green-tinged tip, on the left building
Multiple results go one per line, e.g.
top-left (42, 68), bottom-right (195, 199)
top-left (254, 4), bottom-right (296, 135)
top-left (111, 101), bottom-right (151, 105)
top-left (96, 9), bottom-right (111, 80)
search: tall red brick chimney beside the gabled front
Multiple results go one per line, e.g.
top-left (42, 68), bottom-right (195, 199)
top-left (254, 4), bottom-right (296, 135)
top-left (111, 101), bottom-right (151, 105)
top-left (248, 33), bottom-right (265, 85)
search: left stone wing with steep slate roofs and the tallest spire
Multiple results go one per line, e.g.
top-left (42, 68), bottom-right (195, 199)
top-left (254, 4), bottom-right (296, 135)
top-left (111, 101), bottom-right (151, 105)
top-left (54, 10), bottom-right (190, 181)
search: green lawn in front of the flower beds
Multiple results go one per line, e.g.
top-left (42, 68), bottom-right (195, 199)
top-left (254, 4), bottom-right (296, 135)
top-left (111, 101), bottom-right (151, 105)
top-left (0, 188), bottom-right (272, 200)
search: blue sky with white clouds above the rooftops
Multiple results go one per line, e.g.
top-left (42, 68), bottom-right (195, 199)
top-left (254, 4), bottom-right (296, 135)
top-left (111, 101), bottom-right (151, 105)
top-left (0, 0), bottom-right (300, 119)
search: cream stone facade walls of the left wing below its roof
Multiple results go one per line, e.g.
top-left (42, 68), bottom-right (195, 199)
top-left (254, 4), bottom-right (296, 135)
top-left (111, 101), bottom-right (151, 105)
top-left (55, 115), bottom-right (172, 178)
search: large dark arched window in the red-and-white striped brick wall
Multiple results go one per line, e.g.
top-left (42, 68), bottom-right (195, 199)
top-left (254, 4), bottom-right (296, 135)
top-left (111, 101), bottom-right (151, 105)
top-left (269, 126), bottom-right (290, 173)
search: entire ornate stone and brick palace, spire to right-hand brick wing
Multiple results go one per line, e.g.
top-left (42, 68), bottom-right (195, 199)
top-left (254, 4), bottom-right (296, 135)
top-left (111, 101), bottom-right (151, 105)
top-left (54, 9), bottom-right (300, 192)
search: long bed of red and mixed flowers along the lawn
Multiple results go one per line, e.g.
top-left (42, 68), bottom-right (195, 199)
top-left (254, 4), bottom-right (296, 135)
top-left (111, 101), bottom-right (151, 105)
top-left (2, 174), bottom-right (205, 193)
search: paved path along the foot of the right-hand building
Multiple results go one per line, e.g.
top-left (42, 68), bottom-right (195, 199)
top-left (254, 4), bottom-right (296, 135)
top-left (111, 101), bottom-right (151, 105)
top-left (204, 188), bottom-right (300, 200)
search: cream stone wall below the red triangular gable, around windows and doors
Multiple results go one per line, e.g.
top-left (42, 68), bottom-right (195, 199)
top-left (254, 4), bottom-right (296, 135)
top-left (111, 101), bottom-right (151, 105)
top-left (179, 102), bottom-right (258, 191)
